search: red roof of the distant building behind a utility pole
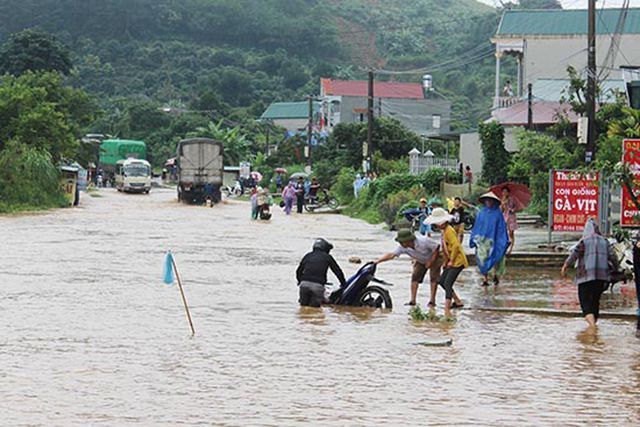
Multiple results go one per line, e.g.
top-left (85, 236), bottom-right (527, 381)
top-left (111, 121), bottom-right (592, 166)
top-left (320, 79), bottom-right (424, 99)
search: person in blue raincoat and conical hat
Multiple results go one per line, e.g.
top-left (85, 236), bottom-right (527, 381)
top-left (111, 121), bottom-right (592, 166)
top-left (469, 192), bottom-right (509, 286)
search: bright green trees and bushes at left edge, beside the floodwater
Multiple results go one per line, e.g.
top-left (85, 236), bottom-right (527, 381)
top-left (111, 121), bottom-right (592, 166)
top-left (0, 71), bottom-right (93, 212)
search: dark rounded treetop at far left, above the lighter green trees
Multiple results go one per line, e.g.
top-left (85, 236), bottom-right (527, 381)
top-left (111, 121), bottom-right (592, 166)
top-left (0, 30), bottom-right (72, 76)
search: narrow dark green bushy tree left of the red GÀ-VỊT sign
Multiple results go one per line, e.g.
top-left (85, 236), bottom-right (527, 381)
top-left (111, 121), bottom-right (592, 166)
top-left (478, 122), bottom-right (510, 185)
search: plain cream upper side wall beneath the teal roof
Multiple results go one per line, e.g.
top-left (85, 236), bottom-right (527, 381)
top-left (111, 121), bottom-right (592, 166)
top-left (524, 34), bottom-right (640, 87)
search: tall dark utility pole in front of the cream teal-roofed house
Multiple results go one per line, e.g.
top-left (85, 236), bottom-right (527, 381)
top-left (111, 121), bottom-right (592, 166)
top-left (585, 0), bottom-right (596, 164)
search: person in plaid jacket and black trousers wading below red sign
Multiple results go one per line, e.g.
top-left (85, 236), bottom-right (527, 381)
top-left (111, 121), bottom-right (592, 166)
top-left (560, 218), bottom-right (618, 330)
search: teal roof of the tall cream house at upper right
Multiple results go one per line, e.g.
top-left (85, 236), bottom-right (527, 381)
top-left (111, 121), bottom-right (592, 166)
top-left (496, 8), bottom-right (640, 36)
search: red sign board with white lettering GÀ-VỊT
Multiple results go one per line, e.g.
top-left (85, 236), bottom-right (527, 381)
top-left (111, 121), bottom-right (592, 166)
top-left (553, 171), bottom-right (599, 231)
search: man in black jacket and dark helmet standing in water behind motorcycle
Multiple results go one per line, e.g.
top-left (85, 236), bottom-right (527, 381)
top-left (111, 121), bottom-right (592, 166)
top-left (296, 239), bottom-right (346, 307)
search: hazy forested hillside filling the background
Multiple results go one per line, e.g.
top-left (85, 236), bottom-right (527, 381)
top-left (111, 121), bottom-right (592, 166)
top-left (0, 0), bottom-right (499, 129)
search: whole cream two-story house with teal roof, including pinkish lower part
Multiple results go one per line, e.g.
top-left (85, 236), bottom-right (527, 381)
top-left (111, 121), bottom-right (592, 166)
top-left (460, 8), bottom-right (640, 181)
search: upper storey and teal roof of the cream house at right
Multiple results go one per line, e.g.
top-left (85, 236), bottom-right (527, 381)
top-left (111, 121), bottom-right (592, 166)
top-left (491, 8), bottom-right (640, 108)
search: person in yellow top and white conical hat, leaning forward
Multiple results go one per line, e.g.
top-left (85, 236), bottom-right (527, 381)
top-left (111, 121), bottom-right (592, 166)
top-left (425, 208), bottom-right (469, 317)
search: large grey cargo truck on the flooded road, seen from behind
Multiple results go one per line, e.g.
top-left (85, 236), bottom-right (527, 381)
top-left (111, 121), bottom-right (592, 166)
top-left (176, 138), bottom-right (224, 204)
